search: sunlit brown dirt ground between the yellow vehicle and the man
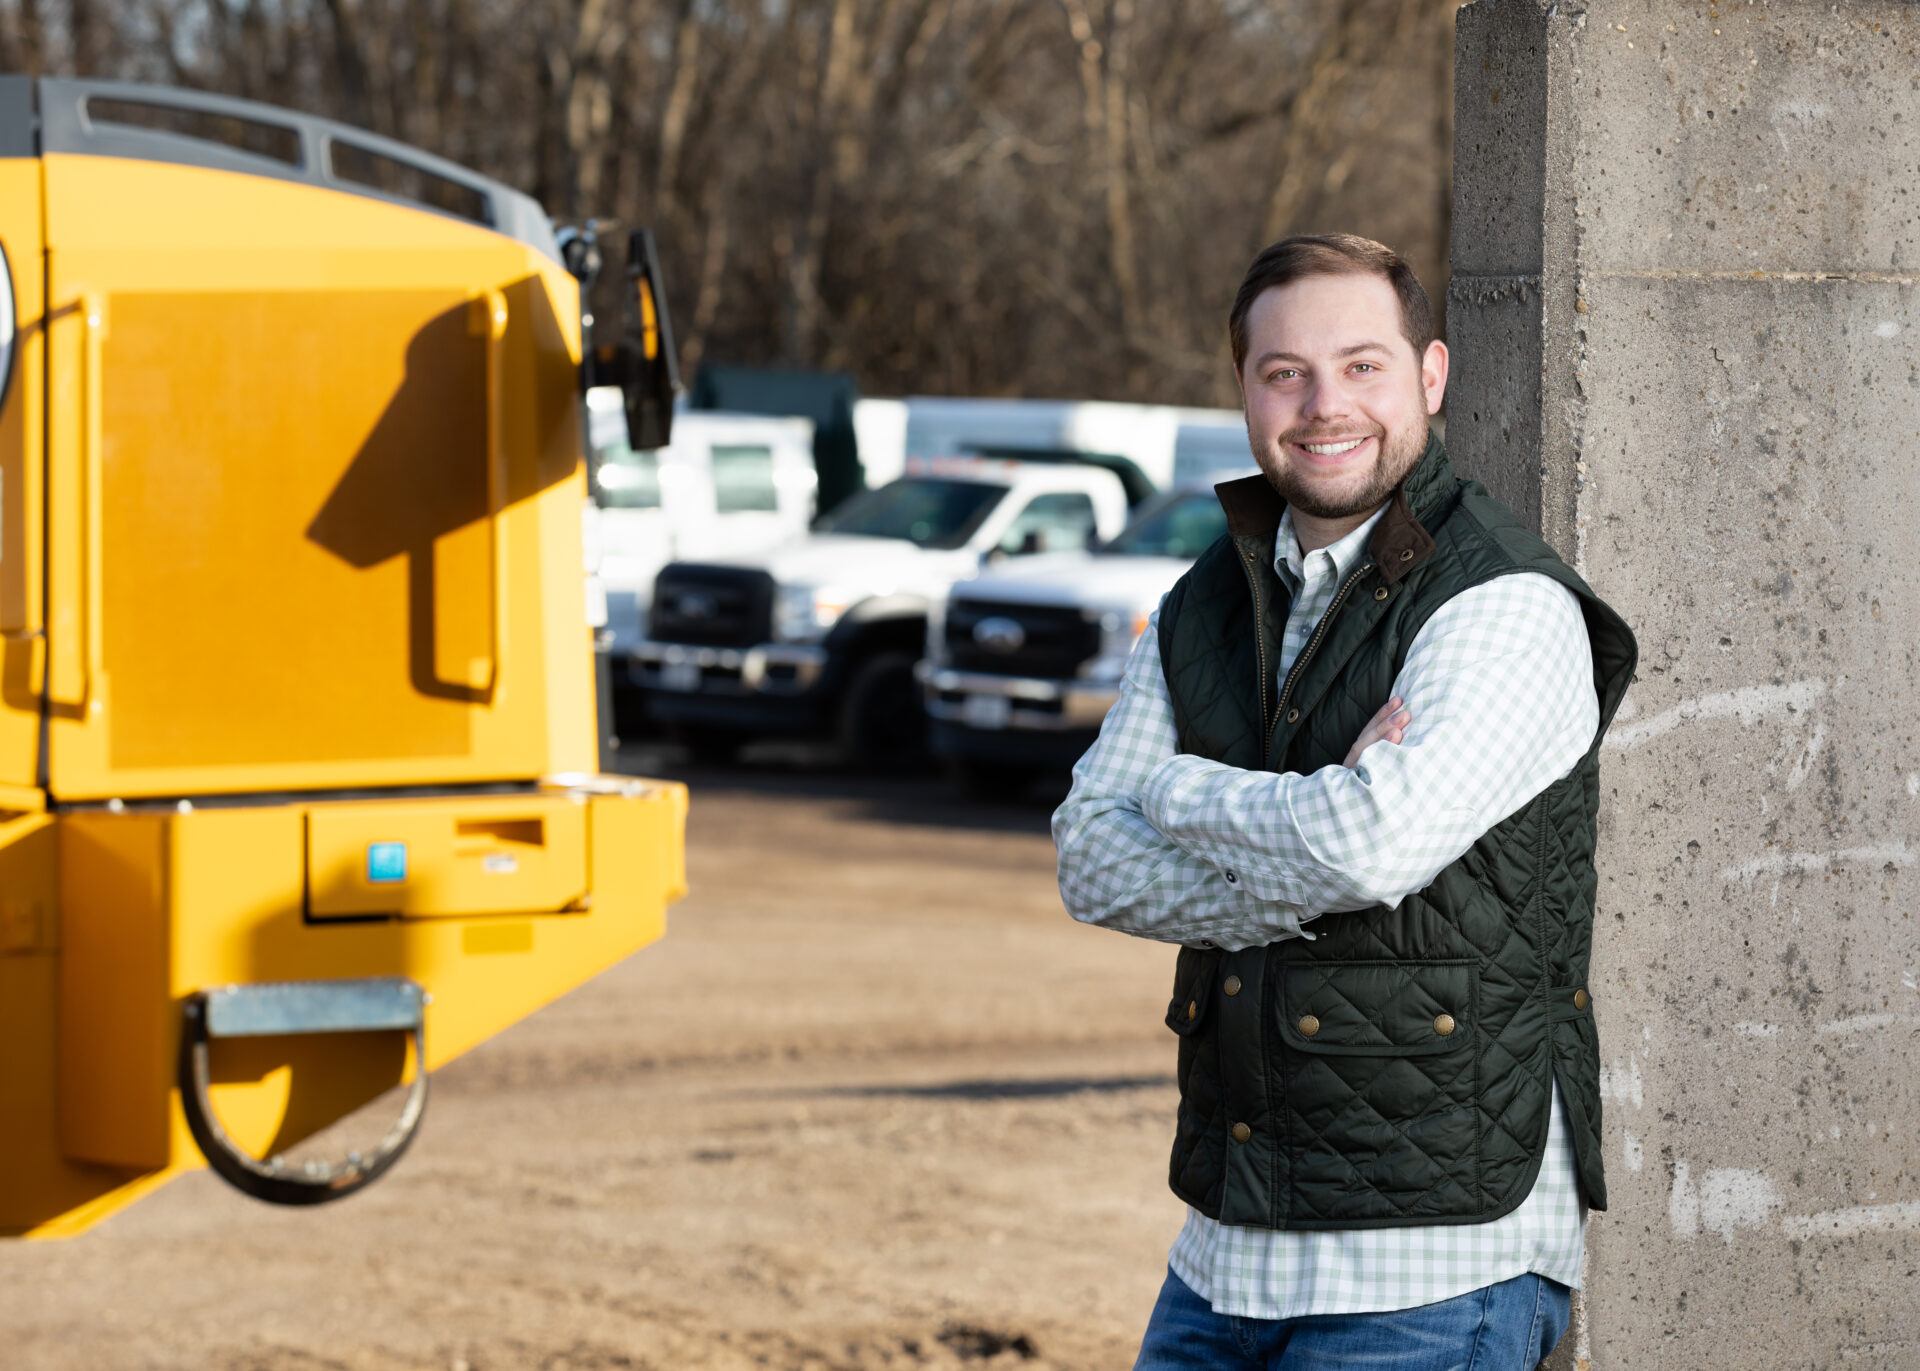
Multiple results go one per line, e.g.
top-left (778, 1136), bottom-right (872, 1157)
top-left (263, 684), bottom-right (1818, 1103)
top-left (0, 753), bottom-right (1183, 1371)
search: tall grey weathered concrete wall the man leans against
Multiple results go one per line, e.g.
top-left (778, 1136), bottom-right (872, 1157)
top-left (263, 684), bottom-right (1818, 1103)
top-left (1448, 0), bottom-right (1920, 1371)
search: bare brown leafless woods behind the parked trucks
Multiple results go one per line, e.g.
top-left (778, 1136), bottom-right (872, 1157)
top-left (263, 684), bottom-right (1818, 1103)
top-left (0, 0), bottom-right (1457, 403)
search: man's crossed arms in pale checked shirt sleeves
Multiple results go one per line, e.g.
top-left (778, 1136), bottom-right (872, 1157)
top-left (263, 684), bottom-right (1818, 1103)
top-left (1054, 572), bottom-right (1599, 949)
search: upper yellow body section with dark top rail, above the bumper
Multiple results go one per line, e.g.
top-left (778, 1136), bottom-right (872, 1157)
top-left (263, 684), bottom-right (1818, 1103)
top-left (42, 81), bottom-right (595, 801)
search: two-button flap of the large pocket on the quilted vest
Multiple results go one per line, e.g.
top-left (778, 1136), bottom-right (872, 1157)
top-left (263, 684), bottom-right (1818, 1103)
top-left (1279, 958), bottom-right (1480, 1056)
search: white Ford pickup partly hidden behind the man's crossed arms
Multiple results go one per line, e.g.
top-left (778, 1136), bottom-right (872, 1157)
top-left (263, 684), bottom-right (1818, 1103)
top-left (918, 486), bottom-right (1227, 799)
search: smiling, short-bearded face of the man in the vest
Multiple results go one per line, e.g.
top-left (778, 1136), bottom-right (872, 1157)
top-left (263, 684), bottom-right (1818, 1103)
top-left (1238, 273), bottom-right (1448, 518)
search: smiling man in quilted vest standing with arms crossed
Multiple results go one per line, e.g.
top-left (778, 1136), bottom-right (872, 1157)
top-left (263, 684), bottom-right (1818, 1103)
top-left (1054, 234), bottom-right (1638, 1371)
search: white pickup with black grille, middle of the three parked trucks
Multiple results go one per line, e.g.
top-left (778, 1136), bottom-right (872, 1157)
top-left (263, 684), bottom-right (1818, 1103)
top-left (626, 457), bottom-right (1127, 766)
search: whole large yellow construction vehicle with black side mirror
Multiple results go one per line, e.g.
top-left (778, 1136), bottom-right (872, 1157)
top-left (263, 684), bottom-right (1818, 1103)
top-left (0, 77), bottom-right (687, 1237)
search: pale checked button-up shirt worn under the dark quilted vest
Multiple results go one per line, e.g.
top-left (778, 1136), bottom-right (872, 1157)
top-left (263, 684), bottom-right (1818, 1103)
top-left (1054, 505), bottom-right (1599, 1319)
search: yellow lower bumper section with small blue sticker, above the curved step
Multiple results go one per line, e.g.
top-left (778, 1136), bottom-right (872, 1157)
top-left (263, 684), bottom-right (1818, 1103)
top-left (0, 778), bottom-right (687, 1237)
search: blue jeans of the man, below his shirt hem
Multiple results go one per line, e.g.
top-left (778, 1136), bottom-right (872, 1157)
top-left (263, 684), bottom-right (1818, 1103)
top-left (1133, 1271), bottom-right (1572, 1371)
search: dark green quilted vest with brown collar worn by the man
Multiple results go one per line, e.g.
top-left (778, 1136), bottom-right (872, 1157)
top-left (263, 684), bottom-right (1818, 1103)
top-left (1160, 438), bottom-right (1638, 1231)
